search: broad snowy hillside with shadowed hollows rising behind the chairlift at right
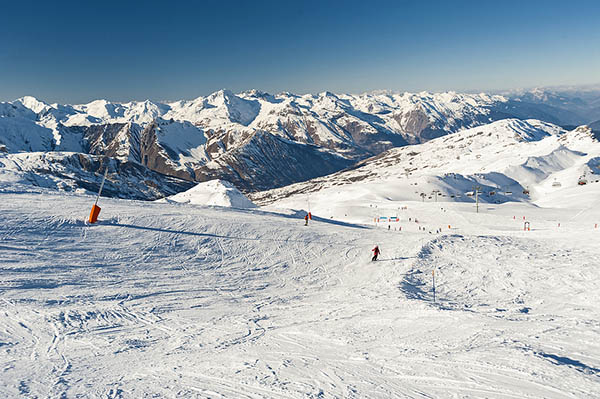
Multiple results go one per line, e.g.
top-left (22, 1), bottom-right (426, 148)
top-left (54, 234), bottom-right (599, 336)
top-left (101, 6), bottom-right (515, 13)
top-left (251, 119), bottom-right (600, 216)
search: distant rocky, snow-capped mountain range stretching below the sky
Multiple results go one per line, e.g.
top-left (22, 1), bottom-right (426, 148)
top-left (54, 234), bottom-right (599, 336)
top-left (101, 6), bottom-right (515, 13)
top-left (0, 90), bottom-right (600, 199)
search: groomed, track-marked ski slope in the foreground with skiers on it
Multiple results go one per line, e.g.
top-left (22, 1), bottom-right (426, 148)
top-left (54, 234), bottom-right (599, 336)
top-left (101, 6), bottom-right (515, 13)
top-left (0, 189), bottom-right (600, 398)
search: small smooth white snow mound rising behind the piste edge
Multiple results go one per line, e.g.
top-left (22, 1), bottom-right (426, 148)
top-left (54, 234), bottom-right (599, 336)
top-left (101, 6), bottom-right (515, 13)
top-left (167, 179), bottom-right (256, 208)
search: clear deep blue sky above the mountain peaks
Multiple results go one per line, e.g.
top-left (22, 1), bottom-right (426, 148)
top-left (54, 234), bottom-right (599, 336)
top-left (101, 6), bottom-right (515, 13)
top-left (0, 0), bottom-right (600, 103)
